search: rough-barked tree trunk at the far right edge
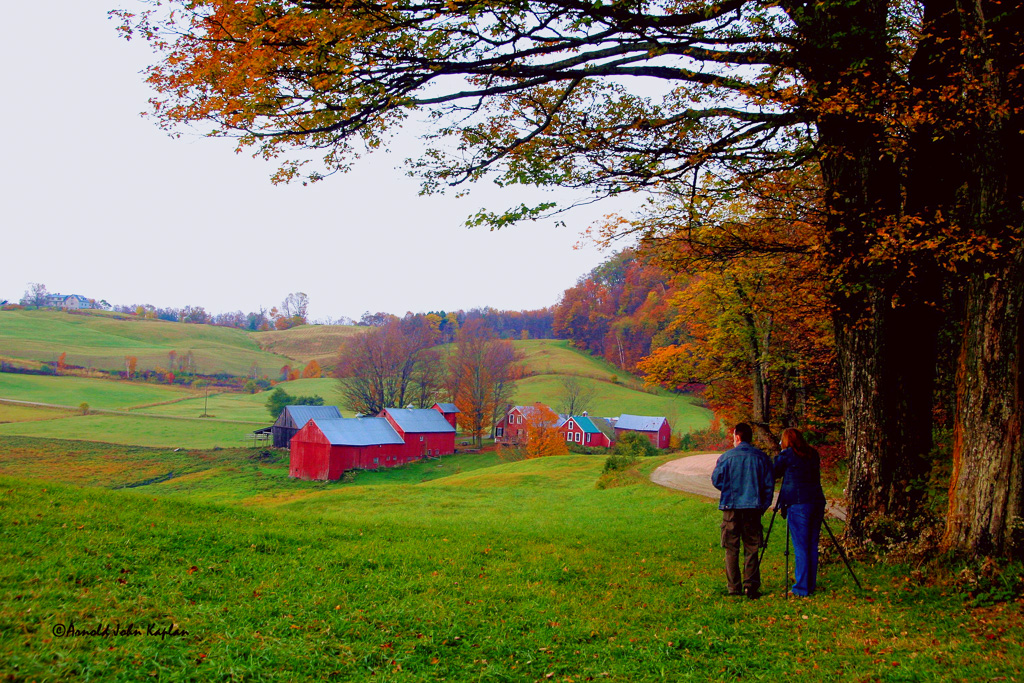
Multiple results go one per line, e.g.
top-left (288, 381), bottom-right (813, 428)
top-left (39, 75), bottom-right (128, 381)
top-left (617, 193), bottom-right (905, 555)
top-left (942, 0), bottom-right (1024, 557)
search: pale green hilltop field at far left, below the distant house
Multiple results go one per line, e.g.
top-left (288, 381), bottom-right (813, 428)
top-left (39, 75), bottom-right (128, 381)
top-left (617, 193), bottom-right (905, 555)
top-left (0, 310), bottom-right (289, 377)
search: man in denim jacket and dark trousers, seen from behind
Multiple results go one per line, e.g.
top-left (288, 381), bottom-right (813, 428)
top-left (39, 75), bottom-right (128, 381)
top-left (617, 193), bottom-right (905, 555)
top-left (711, 422), bottom-right (775, 600)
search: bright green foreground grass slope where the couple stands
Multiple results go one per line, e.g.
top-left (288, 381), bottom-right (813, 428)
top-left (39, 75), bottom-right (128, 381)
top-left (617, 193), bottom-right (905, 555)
top-left (0, 443), bottom-right (1024, 682)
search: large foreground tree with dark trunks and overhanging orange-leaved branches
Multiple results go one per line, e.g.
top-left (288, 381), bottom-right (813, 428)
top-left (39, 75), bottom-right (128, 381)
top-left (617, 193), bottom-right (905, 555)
top-left (119, 0), bottom-right (1024, 556)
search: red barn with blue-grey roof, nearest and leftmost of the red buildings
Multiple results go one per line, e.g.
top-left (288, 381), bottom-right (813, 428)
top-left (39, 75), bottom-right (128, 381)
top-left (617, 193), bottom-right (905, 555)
top-left (288, 418), bottom-right (406, 481)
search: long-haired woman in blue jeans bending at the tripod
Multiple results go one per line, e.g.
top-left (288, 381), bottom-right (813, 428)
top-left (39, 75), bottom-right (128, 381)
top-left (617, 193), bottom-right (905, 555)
top-left (773, 429), bottom-right (825, 596)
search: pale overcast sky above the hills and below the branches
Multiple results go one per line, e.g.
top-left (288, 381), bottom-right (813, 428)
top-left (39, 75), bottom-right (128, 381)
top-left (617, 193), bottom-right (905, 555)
top-left (0, 0), bottom-right (638, 319)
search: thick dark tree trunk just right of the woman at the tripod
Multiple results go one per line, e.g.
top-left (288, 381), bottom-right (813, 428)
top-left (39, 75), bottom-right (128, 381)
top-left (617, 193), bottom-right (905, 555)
top-left (783, 0), bottom-right (937, 542)
